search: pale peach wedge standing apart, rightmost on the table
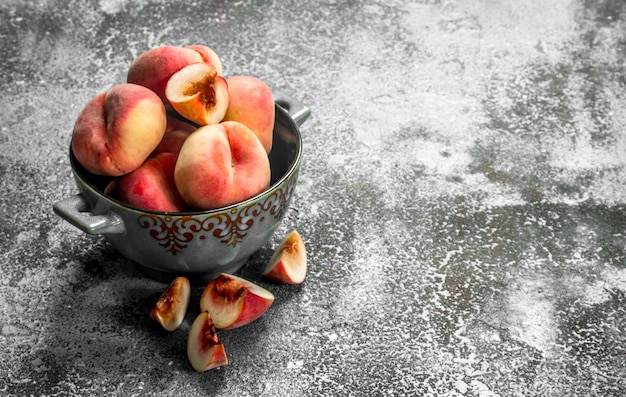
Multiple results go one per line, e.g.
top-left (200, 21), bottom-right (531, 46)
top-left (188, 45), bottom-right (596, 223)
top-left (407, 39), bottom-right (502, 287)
top-left (263, 230), bottom-right (307, 284)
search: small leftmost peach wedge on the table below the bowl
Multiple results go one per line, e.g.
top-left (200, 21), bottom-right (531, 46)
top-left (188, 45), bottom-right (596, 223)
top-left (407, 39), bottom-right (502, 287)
top-left (150, 277), bottom-right (191, 332)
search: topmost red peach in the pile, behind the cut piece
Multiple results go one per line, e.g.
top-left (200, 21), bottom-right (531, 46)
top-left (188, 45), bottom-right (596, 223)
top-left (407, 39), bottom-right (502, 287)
top-left (126, 46), bottom-right (204, 110)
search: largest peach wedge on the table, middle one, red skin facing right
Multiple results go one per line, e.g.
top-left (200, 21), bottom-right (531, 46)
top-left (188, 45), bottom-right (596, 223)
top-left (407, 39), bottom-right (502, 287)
top-left (200, 273), bottom-right (274, 329)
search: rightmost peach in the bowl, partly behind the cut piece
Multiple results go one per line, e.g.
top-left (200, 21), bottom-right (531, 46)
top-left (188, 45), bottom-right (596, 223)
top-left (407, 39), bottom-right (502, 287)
top-left (224, 76), bottom-right (274, 153)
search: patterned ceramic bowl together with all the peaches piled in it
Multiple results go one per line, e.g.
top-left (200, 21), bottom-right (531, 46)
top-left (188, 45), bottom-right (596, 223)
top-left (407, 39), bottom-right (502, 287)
top-left (53, 45), bottom-right (310, 284)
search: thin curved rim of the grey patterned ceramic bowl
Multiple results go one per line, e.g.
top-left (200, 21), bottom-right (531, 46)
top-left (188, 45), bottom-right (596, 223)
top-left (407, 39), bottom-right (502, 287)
top-left (69, 104), bottom-right (302, 216)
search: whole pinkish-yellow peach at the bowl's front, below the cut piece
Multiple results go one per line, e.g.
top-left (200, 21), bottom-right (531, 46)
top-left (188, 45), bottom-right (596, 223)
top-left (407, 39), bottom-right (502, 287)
top-left (174, 121), bottom-right (271, 211)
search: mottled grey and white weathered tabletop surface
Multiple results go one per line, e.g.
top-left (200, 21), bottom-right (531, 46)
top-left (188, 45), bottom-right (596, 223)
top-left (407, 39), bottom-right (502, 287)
top-left (0, 0), bottom-right (626, 397)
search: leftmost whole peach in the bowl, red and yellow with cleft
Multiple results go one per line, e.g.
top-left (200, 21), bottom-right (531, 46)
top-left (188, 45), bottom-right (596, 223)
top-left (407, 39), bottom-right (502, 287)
top-left (72, 84), bottom-right (167, 176)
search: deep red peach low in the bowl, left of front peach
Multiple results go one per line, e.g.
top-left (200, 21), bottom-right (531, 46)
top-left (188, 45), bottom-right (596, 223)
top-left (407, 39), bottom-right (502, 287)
top-left (117, 152), bottom-right (187, 212)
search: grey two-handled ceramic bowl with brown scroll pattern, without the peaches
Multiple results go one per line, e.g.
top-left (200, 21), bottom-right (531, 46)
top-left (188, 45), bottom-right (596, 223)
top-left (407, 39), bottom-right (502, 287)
top-left (53, 93), bottom-right (310, 284)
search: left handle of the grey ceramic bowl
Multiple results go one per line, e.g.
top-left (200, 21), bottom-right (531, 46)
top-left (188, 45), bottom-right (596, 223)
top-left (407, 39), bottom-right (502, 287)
top-left (52, 193), bottom-right (126, 234)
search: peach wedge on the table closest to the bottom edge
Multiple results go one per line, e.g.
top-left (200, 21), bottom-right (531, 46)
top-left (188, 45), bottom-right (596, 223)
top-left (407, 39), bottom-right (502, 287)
top-left (187, 311), bottom-right (228, 372)
